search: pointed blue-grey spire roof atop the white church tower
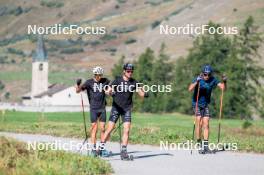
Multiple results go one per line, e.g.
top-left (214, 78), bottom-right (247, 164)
top-left (33, 35), bottom-right (48, 62)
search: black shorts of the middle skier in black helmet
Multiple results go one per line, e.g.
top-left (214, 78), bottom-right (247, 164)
top-left (109, 106), bottom-right (131, 123)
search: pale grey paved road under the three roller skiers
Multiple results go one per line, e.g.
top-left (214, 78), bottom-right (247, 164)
top-left (0, 132), bottom-right (264, 175)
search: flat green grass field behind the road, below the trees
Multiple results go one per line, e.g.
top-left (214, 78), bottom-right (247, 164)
top-left (0, 111), bottom-right (264, 153)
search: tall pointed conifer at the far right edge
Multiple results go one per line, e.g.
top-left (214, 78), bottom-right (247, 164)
top-left (234, 16), bottom-right (264, 118)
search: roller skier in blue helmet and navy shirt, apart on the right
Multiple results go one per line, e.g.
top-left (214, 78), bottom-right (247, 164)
top-left (189, 64), bottom-right (227, 154)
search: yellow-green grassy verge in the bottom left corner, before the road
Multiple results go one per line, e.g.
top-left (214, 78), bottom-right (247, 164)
top-left (0, 137), bottom-right (113, 175)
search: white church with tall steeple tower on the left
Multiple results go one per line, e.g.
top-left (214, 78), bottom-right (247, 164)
top-left (22, 36), bottom-right (88, 106)
